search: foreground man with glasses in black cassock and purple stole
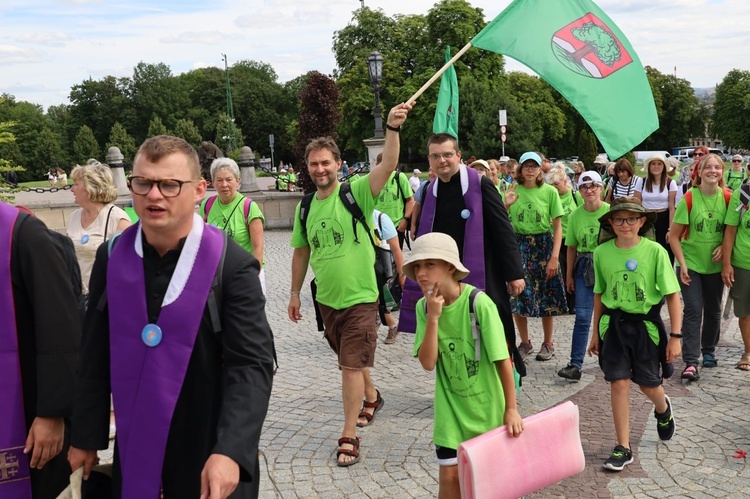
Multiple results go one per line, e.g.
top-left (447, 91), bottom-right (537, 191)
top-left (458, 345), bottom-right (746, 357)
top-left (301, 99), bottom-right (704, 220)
top-left (69, 136), bottom-right (274, 498)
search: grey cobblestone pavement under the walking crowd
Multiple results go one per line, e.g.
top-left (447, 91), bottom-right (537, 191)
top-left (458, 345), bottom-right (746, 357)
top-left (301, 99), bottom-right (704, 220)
top-left (261, 231), bottom-right (750, 499)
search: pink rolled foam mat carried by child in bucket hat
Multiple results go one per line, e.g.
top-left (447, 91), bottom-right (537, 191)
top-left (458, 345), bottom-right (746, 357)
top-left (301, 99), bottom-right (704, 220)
top-left (458, 401), bottom-right (586, 499)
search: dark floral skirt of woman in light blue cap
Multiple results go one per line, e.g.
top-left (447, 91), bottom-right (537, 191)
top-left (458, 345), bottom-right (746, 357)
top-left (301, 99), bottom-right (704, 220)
top-left (510, 232), bottom-right (568, 317)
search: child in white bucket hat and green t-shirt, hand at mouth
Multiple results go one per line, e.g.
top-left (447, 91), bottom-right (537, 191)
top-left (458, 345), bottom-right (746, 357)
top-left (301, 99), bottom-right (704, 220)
top-left (403, 232), bottom-right (523, 499)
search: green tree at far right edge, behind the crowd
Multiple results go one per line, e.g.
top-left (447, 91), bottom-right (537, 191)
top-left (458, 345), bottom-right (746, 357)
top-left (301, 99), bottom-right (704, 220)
top-left (711, 69), bottom-right (750, 149)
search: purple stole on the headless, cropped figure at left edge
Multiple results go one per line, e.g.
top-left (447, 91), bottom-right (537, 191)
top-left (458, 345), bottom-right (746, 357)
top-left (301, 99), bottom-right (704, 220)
top-left (0, 201), bottom-right (31, 499)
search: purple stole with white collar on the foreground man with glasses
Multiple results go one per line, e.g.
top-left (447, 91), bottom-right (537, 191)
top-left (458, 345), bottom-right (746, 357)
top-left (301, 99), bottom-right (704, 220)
top-left (107, 219), bottom-right (224, 499)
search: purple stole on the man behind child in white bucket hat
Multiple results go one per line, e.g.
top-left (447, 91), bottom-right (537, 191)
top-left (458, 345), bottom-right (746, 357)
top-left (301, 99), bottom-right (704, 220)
top-left (398, 165), bottom-right (485, 333)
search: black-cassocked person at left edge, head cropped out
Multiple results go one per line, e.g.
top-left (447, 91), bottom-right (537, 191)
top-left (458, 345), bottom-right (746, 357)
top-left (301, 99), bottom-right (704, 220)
top-left (0, 202), bottom-right (81, 499)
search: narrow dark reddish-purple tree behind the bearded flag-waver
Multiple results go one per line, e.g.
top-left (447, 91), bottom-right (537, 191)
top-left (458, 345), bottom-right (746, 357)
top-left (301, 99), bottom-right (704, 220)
top-left (294, 71), bottom-right (341, 192)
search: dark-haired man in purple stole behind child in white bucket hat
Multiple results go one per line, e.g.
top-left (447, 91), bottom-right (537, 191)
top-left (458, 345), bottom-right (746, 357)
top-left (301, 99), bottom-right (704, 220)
top-left (400, 133), bottom-right (526, 376)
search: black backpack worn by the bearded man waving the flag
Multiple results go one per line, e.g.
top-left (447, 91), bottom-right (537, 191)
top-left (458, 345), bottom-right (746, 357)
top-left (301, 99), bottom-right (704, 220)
top-left (299, 182), bottom-right (393, 331)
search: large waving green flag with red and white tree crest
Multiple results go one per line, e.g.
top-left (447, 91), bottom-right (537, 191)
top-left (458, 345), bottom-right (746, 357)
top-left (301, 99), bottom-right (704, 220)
top-left (471, 0), bottom-right (659, 158)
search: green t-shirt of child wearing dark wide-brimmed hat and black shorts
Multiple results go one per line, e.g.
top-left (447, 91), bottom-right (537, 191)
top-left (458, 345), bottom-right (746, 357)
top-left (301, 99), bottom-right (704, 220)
top-left (594, 237), bottom-right (680, 314)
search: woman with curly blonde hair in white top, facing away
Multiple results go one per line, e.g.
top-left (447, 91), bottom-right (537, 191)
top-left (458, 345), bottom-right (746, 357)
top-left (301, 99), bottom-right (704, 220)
top-left (67, 162), bottom-right (131, 293)
